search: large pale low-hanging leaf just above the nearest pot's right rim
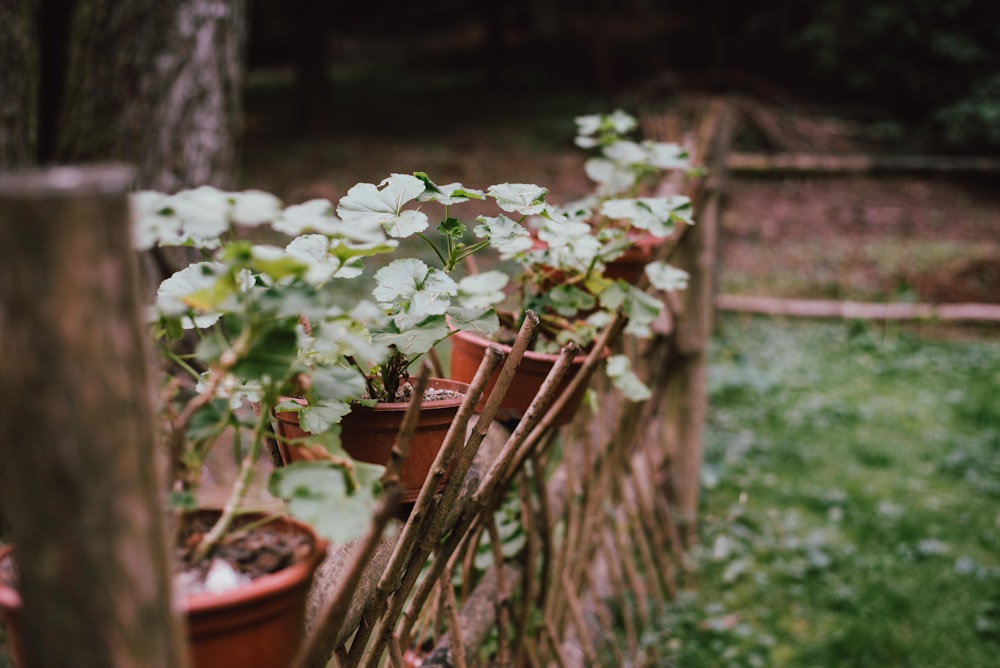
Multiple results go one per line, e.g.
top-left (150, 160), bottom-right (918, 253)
top-left (268, 462), bottom-right (384, 543)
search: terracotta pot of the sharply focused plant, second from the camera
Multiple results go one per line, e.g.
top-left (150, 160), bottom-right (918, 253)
top-left (275, 378), bottom-right (469, 503)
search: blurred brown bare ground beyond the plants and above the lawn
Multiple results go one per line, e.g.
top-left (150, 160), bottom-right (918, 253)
top-left (243, 95), bottom-right (1000, 303)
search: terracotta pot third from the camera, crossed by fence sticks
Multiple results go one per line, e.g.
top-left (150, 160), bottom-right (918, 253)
top-left (450, 332), bottom-right (587, 426)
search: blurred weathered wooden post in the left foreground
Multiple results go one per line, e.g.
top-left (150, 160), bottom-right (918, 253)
top-left (0, 166), bottom-right (187, 667)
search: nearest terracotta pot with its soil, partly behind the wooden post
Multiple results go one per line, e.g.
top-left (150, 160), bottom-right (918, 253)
top-left (0, 511), bottom-right (326, 668)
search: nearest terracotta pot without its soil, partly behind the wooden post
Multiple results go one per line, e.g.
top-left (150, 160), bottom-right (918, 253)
top-left (0, 511), bottom-right (326, 668)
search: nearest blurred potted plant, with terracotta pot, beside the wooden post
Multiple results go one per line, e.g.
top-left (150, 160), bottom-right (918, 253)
top-left (0, 188), bottom-right (393, 667)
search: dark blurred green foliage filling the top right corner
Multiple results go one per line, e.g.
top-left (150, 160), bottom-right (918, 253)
top-left (716, 0), bottom-right (1000, 150)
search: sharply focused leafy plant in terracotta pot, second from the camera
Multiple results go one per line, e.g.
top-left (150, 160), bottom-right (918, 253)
top-left (266, 172), bottom-right (544, 501)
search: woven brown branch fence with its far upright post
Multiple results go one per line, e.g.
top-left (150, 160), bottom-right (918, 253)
top-left (297, 99), bottom-right (732, 668)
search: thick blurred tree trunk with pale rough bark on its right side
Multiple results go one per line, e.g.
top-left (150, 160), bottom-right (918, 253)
top-left (58, 0), bottom-right (246, 192)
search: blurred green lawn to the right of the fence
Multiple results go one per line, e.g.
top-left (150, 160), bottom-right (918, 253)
top-left (649, 318), bottom-right (1000, 668)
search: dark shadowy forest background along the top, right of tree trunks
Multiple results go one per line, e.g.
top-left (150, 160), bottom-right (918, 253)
top-left (248, 0), bottom-right (1000, 152)
